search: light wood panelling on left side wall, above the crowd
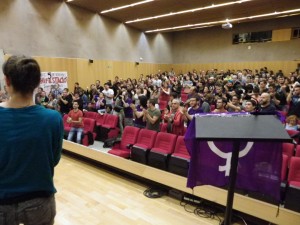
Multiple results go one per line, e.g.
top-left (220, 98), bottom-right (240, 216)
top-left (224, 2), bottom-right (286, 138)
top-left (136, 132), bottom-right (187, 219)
top-left (34, 57), bottom-right (171, 90)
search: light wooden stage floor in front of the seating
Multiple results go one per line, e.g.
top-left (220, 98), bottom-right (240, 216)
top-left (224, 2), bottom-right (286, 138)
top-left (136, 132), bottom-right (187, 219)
top-left (54, 155), bottom-right (223, 225)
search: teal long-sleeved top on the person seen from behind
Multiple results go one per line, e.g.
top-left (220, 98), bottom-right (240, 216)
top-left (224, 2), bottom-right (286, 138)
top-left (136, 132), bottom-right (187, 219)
top-left (0, 105), bottom-right (63, 201)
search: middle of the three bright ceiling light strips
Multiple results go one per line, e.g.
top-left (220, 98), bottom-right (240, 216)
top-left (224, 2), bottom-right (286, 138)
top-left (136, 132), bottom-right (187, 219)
top-left (125, 0), bottom-right (252, 23)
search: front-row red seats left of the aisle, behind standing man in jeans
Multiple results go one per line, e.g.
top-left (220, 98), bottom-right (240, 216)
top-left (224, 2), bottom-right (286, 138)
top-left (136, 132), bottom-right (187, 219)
top-left (63, 112), bottom-right (120, 146)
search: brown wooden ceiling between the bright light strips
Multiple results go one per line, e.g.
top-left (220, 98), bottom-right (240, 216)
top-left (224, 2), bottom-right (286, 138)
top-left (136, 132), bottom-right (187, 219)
top-left (68, 0), bottom-right (300, 31)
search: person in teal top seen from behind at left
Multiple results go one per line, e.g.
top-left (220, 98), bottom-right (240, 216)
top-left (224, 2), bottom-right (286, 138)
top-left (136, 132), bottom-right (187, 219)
top-left (0, 56), bottom-right (63, 225)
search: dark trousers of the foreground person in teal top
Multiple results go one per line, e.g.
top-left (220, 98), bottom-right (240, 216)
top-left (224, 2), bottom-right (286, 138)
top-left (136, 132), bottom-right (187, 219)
top-left (0, 195), bottom-right (56, 225)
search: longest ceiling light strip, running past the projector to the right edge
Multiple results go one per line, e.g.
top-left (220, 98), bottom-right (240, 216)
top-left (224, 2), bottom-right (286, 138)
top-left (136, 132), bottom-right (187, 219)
top-left (145, 9), bottom-right (300, 33)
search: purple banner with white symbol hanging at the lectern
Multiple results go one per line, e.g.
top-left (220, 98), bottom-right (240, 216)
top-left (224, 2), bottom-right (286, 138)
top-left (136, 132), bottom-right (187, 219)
top-left (185, 118), bottom-right (282, 200)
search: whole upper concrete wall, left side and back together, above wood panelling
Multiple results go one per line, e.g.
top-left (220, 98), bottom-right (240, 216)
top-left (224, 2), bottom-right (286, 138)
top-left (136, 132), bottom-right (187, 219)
top-left (0, 0), bottom-right (300, 67)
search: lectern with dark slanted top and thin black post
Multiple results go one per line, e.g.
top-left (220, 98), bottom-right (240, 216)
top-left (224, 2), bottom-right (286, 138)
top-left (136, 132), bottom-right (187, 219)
top-left (195, 114), bottom-right (291, 225)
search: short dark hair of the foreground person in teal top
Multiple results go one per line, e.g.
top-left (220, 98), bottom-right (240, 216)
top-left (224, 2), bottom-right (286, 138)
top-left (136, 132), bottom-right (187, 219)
top-left (2, 56), bottom-right (41, 95)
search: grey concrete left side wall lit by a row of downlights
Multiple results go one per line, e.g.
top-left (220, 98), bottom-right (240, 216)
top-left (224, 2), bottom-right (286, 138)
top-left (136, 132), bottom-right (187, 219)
top-left (0, 0), bottom-right (172, 63)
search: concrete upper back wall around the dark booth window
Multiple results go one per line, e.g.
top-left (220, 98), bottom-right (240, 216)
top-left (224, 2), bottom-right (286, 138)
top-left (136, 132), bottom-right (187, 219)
top-left (172, 16), bottom-right (300, 63)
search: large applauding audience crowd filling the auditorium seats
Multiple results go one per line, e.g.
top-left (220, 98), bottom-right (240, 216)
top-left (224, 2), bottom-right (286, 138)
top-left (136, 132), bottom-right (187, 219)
top-left (0, 67), bottom-right (300, 135)
